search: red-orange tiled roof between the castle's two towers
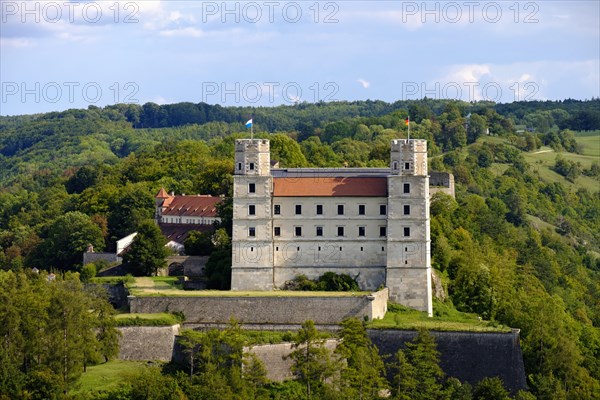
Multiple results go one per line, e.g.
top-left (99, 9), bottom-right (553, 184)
top-left (273, 177), bottom-right (387, 197)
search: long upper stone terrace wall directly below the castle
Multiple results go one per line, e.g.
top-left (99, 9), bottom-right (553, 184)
top-left (129, 289), bottom-right (388, 325)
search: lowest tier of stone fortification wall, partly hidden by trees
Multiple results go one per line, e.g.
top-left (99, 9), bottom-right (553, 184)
top-left (119, 325), bottom-right (527, 393)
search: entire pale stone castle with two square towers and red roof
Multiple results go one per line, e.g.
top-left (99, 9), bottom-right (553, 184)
top-left (231, 139), bottom-right (432, 315)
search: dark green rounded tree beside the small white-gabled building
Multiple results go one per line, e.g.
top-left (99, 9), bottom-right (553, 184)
top-left (123, 221), bottom-right (169, 276)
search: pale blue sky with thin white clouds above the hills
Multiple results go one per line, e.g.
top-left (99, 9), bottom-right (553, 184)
top-left (0, 0), bottom-right (600, 115)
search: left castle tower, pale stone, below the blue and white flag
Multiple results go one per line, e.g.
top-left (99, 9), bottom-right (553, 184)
top-left (231, 139), bottom-right (273, 290)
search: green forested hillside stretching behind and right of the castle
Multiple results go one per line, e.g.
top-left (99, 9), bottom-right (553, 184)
top-left (0, 99), bottom-right (600, 400)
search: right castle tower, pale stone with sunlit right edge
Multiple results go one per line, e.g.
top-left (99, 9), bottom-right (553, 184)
top-left (386, 139), bottom-right (433, 316)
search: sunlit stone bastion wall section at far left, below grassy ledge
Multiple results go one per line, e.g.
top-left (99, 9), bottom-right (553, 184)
top-left (118, 325), bottom-right (179, 361)
